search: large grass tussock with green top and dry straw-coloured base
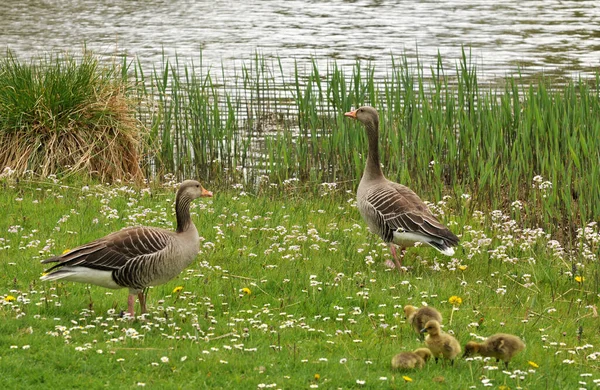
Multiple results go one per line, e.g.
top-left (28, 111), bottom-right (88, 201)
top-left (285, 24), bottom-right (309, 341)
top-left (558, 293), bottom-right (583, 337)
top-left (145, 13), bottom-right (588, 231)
top-left (0, 52), bottom-right (144, 181)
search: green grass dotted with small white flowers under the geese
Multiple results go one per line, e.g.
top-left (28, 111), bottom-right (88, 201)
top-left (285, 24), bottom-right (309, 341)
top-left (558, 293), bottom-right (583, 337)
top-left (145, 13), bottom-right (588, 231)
top-left (0, 178), bottom-right (600, 389)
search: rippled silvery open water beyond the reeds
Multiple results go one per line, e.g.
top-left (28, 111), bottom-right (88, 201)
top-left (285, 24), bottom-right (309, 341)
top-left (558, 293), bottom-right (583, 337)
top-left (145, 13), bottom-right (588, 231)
top-left (0, 0), bottom-right (600, 76)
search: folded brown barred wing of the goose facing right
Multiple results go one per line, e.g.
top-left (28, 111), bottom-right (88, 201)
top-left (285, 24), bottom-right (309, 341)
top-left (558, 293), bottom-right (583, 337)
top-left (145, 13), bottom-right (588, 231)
top-left (42, 226), bottom-right (173, 272)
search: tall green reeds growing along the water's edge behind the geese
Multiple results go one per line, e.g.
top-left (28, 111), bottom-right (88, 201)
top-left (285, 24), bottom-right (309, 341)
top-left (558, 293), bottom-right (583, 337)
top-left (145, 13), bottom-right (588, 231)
top-left (134, 52), bottom-right (600, 236)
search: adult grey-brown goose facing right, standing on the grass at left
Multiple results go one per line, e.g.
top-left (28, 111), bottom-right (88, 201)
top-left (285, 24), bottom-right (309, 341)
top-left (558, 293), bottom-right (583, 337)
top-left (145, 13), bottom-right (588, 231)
top-left (40, 180), bottom-right (212, 317)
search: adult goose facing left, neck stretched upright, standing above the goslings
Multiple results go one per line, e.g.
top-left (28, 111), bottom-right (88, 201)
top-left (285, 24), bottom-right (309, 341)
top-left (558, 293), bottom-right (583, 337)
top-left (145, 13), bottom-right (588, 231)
top-left (344, 106), bottom-right (458, 270)
